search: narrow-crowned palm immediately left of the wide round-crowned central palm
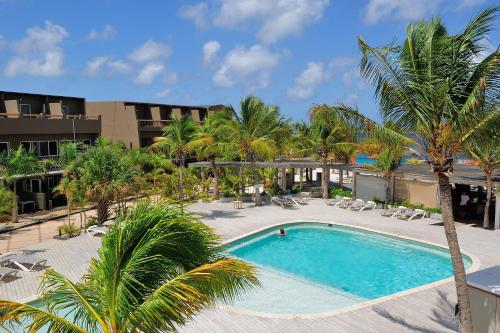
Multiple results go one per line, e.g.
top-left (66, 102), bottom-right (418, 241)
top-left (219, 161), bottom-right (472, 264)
top-left (189, 112), bottom-right (229, 199)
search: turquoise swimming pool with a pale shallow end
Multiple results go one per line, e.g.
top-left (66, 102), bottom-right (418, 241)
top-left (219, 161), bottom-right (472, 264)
top-left (227, 223), bottom-right (472, 314)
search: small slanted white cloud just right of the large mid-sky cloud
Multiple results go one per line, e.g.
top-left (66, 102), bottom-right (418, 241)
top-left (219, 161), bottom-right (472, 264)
top-left (288, 61), bottom-right (327, 99)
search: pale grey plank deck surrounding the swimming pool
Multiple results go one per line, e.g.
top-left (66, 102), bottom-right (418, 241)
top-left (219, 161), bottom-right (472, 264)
top-left (0, 199), bottom-right (500, 332)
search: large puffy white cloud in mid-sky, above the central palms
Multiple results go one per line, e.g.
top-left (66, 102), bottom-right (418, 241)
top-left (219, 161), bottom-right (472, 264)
top-left (212, 45), bottom-right (280, 91)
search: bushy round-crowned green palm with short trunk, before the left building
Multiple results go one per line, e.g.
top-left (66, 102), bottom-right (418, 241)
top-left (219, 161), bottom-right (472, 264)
top-left (61, 138), bottom-right (138, 224)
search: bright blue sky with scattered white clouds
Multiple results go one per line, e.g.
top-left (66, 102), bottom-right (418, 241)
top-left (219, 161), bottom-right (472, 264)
top-left (0, 0), bottom-right (500, 120)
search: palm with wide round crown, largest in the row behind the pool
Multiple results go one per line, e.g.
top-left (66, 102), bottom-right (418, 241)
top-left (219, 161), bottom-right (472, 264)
top-left (221, 96), bottom-right (288, 206)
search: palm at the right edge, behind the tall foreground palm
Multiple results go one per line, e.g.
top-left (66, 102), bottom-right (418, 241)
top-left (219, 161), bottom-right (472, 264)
top-left (466, 124), bottom-right (500, 228)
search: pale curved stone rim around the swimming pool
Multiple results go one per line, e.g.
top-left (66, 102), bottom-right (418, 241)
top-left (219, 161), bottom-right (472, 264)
top-left (217, 220), bottom-right (481, 320)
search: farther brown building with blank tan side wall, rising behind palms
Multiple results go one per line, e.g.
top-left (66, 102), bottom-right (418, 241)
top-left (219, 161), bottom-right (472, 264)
top-left (87, 101), bottom-right (224, 148)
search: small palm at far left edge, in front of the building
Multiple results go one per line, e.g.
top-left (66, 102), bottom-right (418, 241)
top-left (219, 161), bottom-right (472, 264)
top-left (0, 146), bottom-right (45, 222)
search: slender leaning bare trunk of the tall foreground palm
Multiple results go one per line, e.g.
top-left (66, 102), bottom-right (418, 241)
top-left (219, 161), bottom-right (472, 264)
top-left (438, 173), bottom-right (472, 333)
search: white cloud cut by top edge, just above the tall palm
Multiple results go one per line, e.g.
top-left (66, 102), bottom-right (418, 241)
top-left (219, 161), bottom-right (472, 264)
top-left (363, 0), bottom-right (441, 24)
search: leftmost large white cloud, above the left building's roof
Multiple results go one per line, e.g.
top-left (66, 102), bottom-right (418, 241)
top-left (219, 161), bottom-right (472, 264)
top-left (4, 21), bottom-right (68, 77)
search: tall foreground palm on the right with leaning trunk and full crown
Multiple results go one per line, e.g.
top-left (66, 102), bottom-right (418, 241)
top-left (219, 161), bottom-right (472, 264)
top-left (316, 8), bottom-right (500, 333)
